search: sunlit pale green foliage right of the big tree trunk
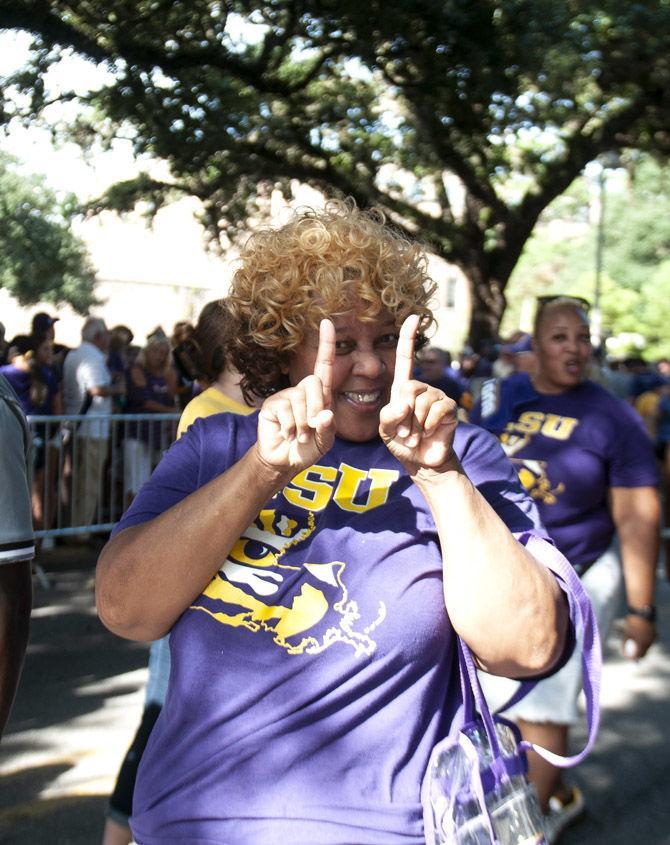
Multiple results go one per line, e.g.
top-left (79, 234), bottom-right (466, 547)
top-left (503, 155), bottom-right (670, 358)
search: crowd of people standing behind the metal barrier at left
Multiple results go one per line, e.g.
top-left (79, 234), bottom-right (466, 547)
top-left (0, 312), bottom-right (210, 542)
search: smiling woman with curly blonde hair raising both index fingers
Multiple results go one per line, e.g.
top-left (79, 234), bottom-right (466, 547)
top-left (96, 203), bottom-right (570, 845)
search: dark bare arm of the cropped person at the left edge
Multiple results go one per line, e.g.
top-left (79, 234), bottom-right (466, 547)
top-left (0, 560), bottom-right (32, 736)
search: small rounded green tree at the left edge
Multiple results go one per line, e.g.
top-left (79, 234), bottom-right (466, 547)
top-left (0, 155), bottom-right (96, 313)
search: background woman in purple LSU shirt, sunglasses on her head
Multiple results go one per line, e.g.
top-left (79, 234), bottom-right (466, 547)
top-left (471, 297), bottom-right (660, 843)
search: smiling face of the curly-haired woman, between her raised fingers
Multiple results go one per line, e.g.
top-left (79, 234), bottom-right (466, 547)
top-left (288, 311), bottom-right (398, 443)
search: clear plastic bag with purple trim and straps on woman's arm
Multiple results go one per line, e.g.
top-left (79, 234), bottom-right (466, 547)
top-left (421, 548), bottom-right (601, 845)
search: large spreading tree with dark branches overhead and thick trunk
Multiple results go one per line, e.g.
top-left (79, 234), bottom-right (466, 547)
top-left (0, 0), bottom-right (670, 342)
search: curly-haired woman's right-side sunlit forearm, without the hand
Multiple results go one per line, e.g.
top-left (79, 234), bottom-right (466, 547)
top-left (414, 466), bottom-right (568, 677)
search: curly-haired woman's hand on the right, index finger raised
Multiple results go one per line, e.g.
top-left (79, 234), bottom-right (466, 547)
top-left (379, 314), bottom-right (458, 476)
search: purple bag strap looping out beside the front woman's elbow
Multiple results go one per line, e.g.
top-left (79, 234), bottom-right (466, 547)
top-left (488, 534), bottom-right (602, 769)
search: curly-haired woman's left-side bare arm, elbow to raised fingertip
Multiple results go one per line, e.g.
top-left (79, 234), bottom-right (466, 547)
top-left (96, 323), bottom-right (335, 640)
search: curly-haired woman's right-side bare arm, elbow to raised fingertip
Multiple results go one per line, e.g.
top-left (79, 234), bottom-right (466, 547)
top-left (380, 318), bottom-right (568, 677)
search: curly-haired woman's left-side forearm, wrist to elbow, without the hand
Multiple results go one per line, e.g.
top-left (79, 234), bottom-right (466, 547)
top-left (96, 445), bottom-right (290, 640)
